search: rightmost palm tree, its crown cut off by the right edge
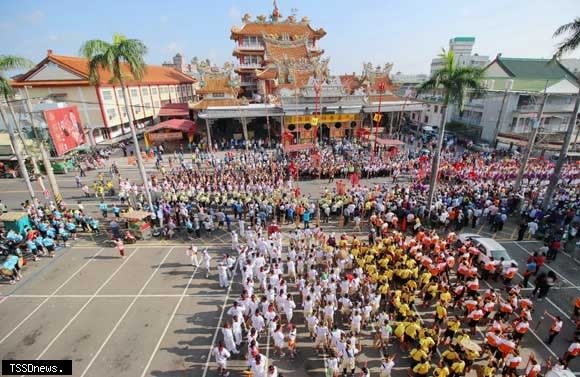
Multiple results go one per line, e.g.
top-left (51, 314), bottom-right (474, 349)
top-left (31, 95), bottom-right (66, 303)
top-left (542, 17), bottom-right (580, 210)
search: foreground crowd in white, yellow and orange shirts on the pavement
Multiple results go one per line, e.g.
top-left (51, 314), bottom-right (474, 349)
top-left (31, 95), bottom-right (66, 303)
top-left (207, 219), bottom-right (580, 377)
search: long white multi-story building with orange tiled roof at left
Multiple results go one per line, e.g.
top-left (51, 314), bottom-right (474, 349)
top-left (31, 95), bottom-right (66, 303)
top-left (12, 50), bottom-right (195, 143)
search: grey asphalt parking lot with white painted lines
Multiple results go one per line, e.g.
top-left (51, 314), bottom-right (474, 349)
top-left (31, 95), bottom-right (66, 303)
top-left (0, 234), bottom-right (580, 377)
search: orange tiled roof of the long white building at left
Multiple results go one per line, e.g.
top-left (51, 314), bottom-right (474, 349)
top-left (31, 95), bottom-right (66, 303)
top-left (15, 52), bottom-right (195, 86)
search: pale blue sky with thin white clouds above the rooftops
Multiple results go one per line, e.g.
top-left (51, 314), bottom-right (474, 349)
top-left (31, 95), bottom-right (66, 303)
top-left (0, 0), bottom-right (580, 74)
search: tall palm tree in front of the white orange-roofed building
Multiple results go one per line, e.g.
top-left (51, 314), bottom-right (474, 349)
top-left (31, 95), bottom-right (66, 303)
top-left (80, 34), bottom-right (154, 211)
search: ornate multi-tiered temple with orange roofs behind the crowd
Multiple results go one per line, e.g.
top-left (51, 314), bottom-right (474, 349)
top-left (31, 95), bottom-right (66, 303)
top-left (193, 1), bottom-right (425, 149)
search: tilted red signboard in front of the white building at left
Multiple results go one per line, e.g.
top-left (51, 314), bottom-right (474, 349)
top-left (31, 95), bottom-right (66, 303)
top-left (44, 106), bottom-right (85, 156)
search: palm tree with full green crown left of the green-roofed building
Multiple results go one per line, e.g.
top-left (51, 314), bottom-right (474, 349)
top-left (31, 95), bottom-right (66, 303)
top-left (420, 50), bottom-right (483, 216)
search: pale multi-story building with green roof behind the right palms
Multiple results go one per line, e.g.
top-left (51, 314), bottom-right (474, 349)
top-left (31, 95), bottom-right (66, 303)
top-left (450, 54), bottom-right (578, 149)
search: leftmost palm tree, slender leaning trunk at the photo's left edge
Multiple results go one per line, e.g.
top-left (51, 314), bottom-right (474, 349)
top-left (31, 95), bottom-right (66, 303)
top-left (0, 55), bottom-right (35, 201)
